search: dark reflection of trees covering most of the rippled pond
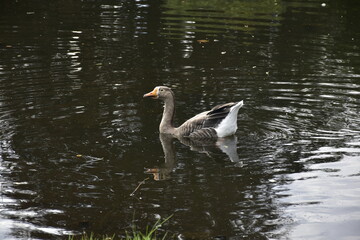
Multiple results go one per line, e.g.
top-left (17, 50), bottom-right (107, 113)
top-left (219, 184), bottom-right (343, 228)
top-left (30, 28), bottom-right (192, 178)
top-left (0, 1), bottom-right (359, 239)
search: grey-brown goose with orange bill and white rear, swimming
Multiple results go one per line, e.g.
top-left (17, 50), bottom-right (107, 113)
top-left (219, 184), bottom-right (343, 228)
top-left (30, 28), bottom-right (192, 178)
top-left (143, 86), bottom-right (244, 138)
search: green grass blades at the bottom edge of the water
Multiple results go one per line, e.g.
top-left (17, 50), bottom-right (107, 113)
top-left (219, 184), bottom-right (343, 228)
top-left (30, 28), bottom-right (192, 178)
top-left (68, 215), bottom-right (172, 240)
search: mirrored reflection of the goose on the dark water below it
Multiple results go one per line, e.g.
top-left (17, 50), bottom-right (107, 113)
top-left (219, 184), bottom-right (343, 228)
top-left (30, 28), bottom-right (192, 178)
top-left (145, 134), bottom-right (242, 181)
